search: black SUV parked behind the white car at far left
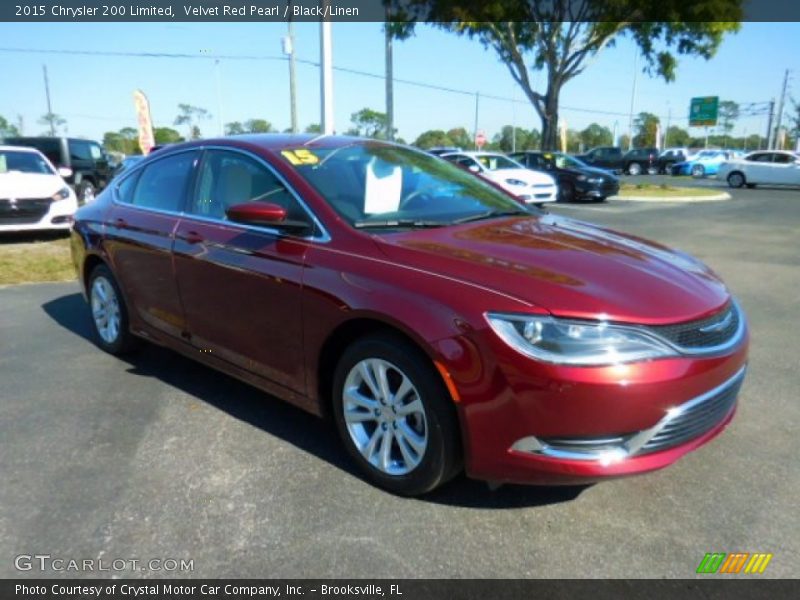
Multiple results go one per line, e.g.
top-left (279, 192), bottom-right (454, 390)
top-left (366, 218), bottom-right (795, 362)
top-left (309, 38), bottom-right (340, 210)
top-left (4, 137), bottom-right (111, 204)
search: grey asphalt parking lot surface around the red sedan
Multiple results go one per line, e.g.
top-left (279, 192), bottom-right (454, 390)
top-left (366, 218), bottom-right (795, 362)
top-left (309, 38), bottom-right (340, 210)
top-left (0, 178), bottom-right (800, 578)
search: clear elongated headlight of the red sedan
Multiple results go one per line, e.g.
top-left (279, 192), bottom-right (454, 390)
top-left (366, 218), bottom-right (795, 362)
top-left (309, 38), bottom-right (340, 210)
top-left (486, 313), bottom-right (677, 366)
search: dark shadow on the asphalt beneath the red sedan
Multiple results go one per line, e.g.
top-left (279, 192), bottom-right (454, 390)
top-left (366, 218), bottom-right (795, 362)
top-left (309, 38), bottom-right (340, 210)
top-left (42, 293), bottom-right (588, 509)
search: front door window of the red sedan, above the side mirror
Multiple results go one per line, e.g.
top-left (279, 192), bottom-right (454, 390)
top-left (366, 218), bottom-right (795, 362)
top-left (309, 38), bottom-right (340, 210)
top-left (188, 150), bottom-right (308, 221)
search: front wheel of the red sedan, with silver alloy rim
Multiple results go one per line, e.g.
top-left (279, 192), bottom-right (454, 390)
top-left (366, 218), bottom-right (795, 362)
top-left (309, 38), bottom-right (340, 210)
top-left (333, 334), bottom-right (461, 496)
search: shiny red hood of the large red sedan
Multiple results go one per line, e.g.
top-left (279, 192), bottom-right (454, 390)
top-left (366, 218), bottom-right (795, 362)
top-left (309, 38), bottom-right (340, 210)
top-left (376, 215), bottom-right (730, 324)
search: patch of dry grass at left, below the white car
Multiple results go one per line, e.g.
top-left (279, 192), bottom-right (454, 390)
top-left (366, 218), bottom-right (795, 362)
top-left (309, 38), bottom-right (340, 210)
top-left (0, 234), bottom-right (76, 285)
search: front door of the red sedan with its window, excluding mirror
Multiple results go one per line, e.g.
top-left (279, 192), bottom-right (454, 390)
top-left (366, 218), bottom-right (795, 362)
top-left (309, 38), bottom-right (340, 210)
top-left (174, 149), bottom-right (313, 393)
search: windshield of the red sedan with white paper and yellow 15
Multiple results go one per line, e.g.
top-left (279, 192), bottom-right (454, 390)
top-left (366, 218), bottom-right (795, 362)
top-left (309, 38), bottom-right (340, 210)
top-left (281, 143), bottom-right (530, 228)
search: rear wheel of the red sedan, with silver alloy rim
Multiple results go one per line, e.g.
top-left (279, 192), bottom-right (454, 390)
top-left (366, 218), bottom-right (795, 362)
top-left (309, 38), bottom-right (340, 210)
top-left (88, 265), bottom-right (136, 355)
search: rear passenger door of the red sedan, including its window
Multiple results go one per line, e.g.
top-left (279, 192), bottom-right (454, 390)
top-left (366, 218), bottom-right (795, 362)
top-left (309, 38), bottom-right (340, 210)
top-left (105, 150), bottom-right (199, 337)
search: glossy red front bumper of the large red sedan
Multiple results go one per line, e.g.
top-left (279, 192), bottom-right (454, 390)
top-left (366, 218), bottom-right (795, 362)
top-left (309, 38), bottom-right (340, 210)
top-left (434, 326), bottom-right (748, 485)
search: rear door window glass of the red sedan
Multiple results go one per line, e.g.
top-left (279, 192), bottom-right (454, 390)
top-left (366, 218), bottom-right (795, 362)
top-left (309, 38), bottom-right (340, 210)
top-left (131, 152), bottom-right (197, 212)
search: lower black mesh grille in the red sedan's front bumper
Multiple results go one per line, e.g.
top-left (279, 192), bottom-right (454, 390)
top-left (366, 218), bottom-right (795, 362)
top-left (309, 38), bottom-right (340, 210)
top-left (638, 371), bottom-right (744, 454)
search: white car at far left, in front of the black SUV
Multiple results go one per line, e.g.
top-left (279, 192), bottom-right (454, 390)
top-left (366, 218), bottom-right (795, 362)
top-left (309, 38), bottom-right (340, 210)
top-left (0, 146), bottom-right (78, 232)
